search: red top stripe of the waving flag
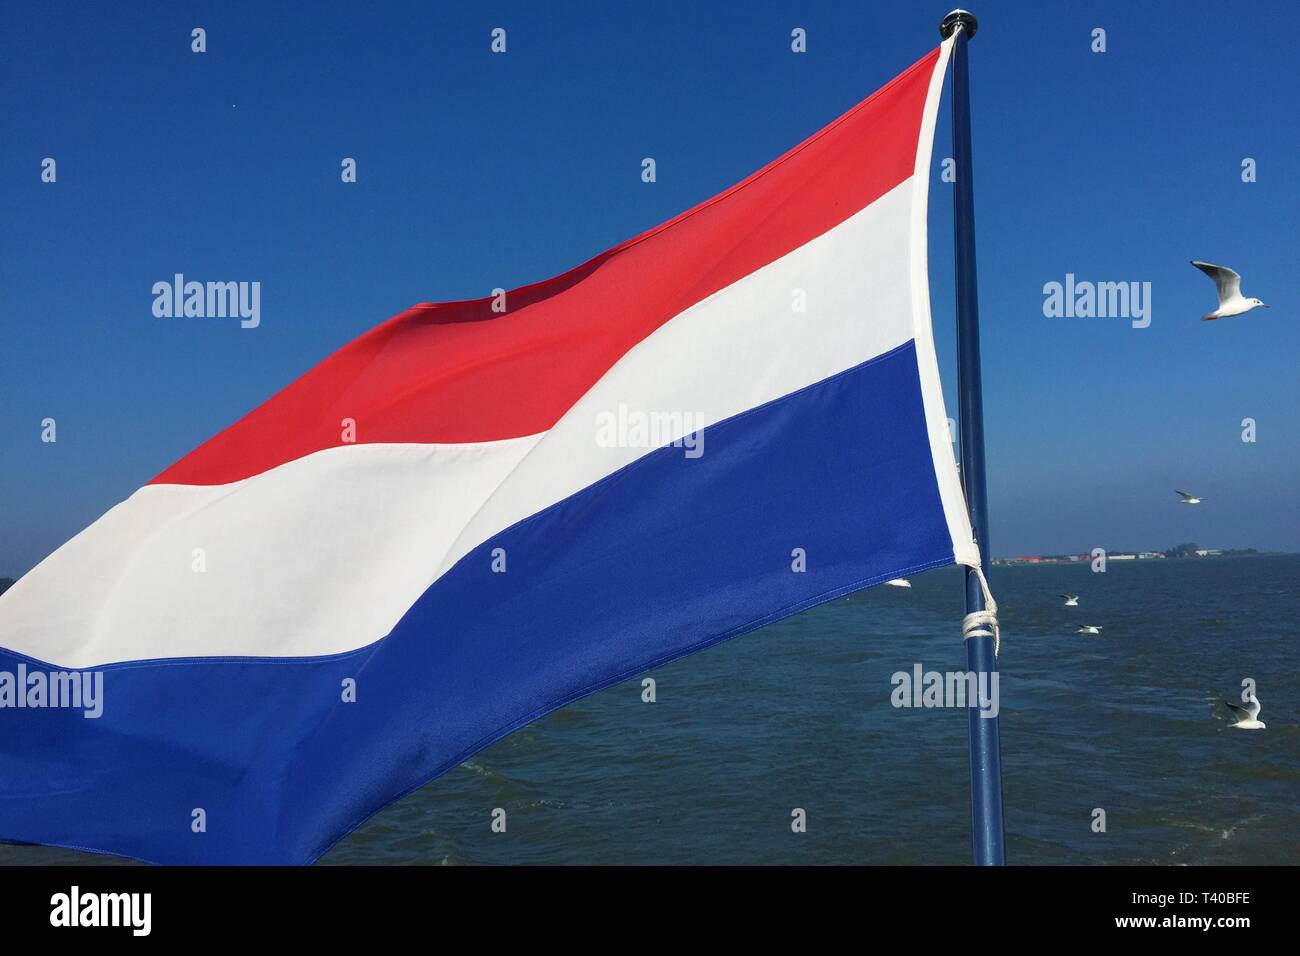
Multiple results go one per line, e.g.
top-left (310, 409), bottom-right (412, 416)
top-left (153, 49), bottom-right (939, 485)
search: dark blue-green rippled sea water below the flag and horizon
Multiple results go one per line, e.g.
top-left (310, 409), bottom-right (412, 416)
top-left (0, 555), bottom-right (1300, 865)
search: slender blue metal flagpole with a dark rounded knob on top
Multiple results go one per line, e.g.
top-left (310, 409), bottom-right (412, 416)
top-left (939, 10), bottom-right (1006, 866)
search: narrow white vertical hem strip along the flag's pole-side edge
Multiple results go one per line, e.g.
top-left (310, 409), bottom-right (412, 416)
top-left (910, 36), bottom-right (980, 567)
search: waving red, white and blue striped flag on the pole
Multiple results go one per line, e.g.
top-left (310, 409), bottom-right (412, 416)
top-left (0, 44), bottom-right (979, 862)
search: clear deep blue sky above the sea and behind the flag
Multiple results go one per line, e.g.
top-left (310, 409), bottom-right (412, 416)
top-left (0, 0), bottom-right (1300, 576)
